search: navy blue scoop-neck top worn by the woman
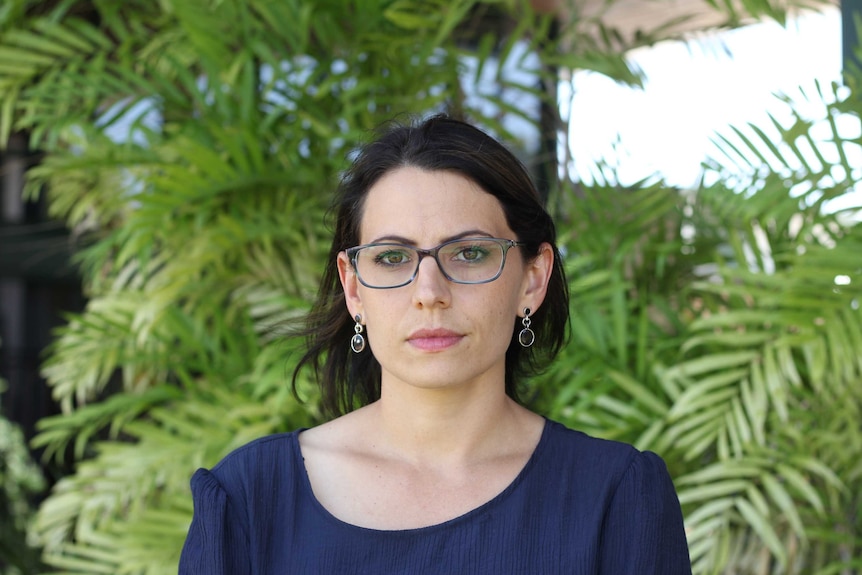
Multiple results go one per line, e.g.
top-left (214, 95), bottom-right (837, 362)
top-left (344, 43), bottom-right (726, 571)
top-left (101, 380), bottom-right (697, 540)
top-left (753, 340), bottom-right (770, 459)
top-left (179, 420), bottom-right (691, 575)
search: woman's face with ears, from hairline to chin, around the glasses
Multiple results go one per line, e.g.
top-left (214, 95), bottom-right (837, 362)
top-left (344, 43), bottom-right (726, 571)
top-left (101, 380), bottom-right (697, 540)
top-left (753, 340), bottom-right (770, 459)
top-left (338, 167), bottom-right (553, 389)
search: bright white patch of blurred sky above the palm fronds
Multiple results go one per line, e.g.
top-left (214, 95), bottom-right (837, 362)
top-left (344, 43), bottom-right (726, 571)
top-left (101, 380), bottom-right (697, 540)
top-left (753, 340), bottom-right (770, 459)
top-left (563, 7), bottom-right (862, 197)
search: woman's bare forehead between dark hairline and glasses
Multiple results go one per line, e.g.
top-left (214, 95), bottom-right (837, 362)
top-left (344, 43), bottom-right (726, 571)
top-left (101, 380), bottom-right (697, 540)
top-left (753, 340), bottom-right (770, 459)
top-left (359, 167), bottom-right (513, 246)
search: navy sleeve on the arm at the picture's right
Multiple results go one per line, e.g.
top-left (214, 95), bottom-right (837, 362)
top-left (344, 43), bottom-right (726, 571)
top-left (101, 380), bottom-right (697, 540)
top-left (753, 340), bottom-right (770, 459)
top-left (600, 452), bottom-right (691, 575)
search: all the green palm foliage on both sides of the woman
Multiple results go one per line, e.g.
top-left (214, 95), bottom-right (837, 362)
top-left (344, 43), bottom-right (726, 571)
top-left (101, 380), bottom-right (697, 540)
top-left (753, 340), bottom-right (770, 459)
top-left (0, 0), bottom-right (862, 574)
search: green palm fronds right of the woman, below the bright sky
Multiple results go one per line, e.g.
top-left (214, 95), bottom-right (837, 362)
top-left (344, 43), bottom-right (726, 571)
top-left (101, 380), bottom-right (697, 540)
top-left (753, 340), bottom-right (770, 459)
top-left (541, 75), bottom-right (862, 573)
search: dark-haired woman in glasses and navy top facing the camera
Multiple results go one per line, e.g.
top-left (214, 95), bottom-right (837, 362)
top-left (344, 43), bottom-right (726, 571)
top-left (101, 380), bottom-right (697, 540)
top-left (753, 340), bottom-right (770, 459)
top-left (180, 116), bottom-right (690, 575)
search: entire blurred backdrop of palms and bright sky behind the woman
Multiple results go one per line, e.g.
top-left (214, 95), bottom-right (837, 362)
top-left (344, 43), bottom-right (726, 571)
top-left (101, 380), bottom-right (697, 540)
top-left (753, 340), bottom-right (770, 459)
top-left (0, 0), bottom-right (862, 575)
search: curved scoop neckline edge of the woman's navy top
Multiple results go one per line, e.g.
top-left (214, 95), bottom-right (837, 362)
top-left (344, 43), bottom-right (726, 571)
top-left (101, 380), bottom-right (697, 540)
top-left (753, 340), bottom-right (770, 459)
top-left (292, 417), bottom-right (552, 535)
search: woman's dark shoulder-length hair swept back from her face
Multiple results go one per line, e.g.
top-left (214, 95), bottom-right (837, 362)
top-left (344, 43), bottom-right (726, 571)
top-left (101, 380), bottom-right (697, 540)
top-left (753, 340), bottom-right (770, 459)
top-left (293, 116), bottom-right (569, 415)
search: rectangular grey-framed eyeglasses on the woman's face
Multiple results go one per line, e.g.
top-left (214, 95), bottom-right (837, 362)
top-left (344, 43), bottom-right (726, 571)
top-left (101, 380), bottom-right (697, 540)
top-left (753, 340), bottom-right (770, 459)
top-left (347, 238), bottom-right (525, 289)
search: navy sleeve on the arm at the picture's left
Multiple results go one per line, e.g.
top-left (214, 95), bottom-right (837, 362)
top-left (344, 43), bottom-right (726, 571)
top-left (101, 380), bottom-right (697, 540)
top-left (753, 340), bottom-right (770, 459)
top-left (179, 469), bottom-right (250, 575)
